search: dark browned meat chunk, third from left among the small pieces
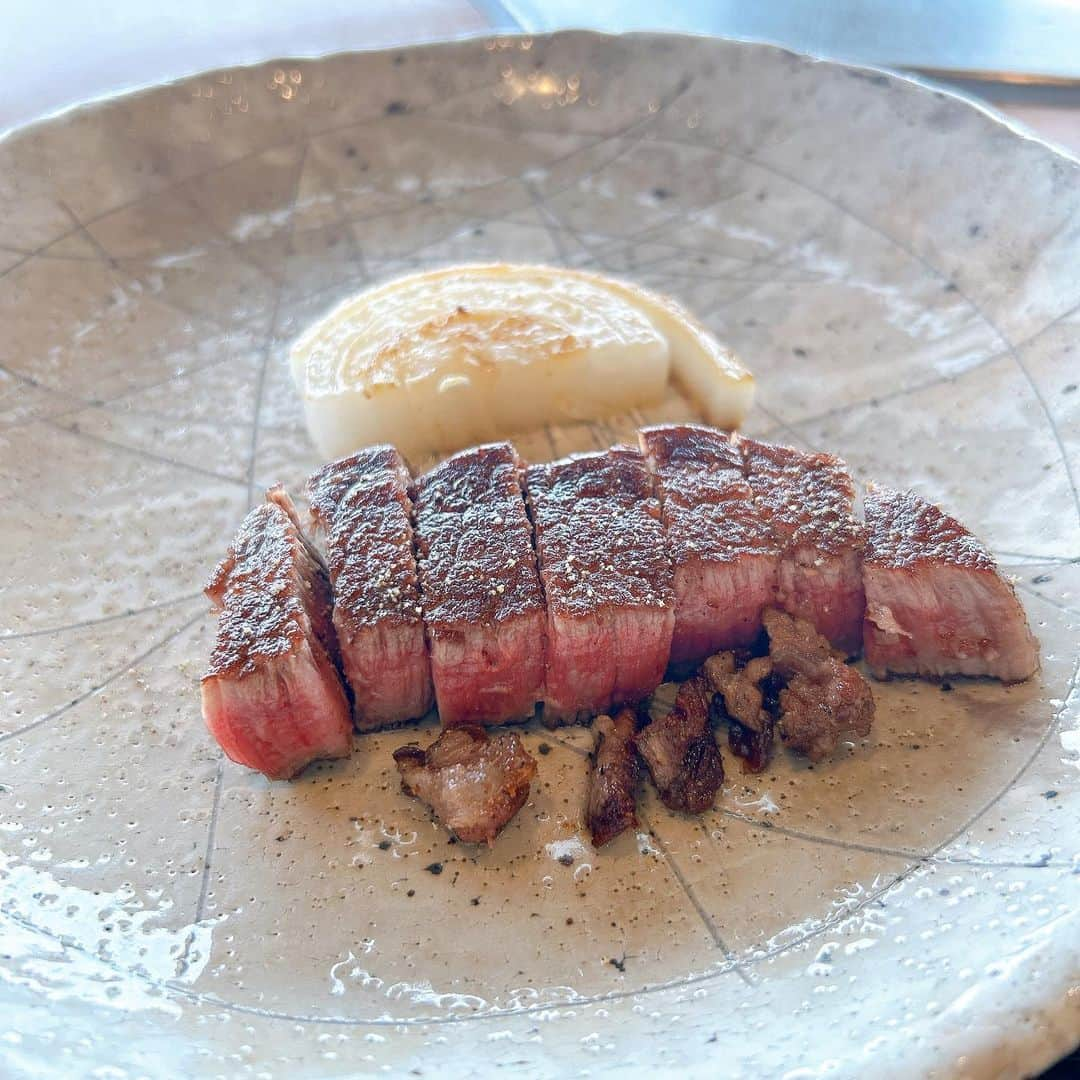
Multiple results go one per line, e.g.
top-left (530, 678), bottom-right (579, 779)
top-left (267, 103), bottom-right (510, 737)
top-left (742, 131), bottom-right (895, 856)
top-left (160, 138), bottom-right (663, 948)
top-left (635, 675), bottom-right (724, 813)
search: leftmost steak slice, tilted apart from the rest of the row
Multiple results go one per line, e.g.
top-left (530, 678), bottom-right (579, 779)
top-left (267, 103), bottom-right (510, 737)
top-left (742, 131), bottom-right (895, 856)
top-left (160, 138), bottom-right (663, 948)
top-left (202, 488), bottom-right (352, 780)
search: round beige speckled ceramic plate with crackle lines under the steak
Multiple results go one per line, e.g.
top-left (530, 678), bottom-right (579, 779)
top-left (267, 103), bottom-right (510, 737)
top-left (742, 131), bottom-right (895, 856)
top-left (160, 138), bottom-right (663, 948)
top-left (0, 33), bottom-right (1080, 1077)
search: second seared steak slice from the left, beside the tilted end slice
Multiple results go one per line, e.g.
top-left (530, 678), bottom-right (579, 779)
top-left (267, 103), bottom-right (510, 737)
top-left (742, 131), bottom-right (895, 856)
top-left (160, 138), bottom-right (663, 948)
top-left (308, 446), bottom-right (434, 731)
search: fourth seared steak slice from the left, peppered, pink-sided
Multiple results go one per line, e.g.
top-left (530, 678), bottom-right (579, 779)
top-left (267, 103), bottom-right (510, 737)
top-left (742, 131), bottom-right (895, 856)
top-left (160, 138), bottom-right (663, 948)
top-left (525, 446), bottom-right (675, 723)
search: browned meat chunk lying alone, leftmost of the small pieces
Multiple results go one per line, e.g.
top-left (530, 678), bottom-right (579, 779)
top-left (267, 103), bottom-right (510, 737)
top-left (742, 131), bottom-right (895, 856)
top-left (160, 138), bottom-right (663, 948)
top-left (394, 726), bottom-right (537, 845)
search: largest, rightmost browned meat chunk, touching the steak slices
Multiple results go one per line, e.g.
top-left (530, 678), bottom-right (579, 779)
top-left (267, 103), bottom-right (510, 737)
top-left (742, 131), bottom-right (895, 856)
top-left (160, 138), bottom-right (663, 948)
top-left (765, 610), bottom-right (874, 761)
